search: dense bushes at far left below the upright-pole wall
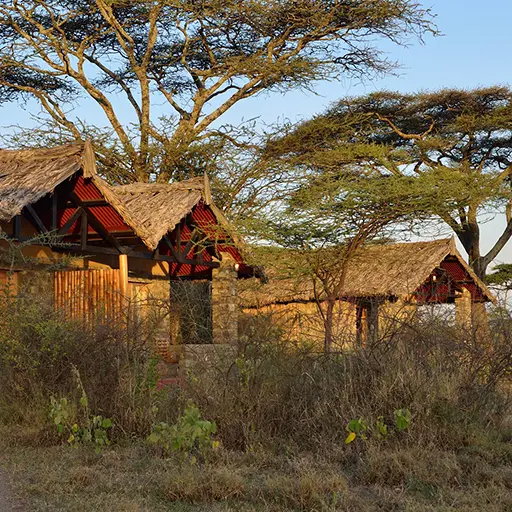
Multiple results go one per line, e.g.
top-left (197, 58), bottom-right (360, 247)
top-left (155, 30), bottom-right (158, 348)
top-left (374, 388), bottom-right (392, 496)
top-left (0, 288), bottom-right (159, 437)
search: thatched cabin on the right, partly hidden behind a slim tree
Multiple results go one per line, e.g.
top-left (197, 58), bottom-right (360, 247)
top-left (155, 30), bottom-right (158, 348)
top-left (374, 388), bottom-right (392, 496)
top-left (240, 239), bottom-right (495, 346)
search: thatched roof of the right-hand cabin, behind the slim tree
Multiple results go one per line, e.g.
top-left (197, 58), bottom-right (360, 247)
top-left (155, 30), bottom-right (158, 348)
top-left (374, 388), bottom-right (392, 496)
top-left (240, 238), bottom-right (494, 307)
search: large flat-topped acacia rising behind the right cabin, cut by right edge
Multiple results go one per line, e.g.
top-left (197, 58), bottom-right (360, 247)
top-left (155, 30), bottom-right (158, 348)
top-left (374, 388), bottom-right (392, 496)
top-left (268, 87), bottom-right (512, 279)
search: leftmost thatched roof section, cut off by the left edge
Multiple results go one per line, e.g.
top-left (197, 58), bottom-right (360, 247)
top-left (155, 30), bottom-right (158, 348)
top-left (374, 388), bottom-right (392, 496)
top-left (0, 144), bottom-right (94, 221)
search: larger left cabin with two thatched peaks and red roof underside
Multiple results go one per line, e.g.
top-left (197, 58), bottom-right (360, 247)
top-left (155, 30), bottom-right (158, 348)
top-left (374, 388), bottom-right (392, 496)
top-left (0, 143), bottom-right (254, 352)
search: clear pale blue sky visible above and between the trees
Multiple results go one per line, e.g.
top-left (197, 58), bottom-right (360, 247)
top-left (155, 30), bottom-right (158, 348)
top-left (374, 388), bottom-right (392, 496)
top-left (0, 0), bottom-right (512, 262)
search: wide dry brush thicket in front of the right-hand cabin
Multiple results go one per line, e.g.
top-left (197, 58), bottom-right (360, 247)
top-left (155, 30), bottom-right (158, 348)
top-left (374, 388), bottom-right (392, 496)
top-left (186, 314), bottom-right (512, 453)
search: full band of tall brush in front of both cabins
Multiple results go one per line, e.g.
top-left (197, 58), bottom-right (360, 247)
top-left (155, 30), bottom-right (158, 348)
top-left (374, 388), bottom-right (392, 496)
top-left (0, 284), bottom-right (512, 460)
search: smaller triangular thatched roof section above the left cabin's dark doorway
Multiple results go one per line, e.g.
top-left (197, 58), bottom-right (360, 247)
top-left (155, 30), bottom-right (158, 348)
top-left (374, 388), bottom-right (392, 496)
top-left (112, 176), bottom-right (211, 249)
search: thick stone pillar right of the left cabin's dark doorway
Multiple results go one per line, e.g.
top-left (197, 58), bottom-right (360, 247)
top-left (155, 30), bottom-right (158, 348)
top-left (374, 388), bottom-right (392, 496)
top-left (212, 253), bottom-right (238, 345)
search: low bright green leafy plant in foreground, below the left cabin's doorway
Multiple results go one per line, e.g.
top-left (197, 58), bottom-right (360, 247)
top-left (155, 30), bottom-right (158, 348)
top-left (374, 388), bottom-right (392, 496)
top-left (148, 402), bottom-right (219, 463)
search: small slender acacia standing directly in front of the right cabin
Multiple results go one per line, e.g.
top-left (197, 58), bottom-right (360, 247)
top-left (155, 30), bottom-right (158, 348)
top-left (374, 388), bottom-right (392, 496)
top-left (265, 172), bottom-right (418, 353)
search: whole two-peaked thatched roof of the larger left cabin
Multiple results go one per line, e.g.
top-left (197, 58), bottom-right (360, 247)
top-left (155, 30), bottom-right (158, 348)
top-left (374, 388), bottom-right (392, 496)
top-left (0, 142), bottom-right (233, 250)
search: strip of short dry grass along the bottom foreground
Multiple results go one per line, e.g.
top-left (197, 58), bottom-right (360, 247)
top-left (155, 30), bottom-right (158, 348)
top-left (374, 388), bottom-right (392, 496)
top-left (0, 436), bottom-right (512, 512)
